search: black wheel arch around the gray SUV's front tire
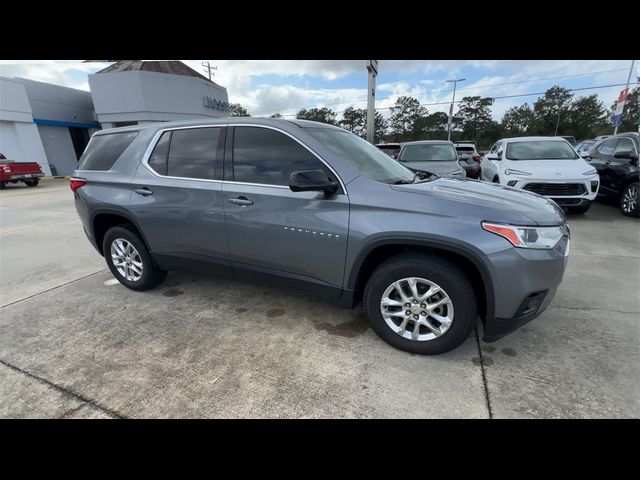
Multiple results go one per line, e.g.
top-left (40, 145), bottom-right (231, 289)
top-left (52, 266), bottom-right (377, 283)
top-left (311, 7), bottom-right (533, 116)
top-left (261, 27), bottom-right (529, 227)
top-left (346, 237), bottom-right (495, 322)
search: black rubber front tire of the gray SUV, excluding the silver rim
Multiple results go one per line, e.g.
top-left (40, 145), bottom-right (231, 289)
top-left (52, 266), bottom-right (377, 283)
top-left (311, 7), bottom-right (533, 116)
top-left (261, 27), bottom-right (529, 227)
top-left (363, 253), bottom-right (477, 355)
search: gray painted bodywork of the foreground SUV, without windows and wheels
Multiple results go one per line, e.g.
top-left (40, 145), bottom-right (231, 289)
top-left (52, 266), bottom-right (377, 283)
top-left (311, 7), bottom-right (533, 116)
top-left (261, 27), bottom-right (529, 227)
top-left (74, 118), bottom-right (567, 344)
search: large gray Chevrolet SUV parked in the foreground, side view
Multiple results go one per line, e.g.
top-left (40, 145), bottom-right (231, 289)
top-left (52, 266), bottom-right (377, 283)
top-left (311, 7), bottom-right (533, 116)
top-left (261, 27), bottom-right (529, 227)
top-left (71, 118), bottom-right (569, 354)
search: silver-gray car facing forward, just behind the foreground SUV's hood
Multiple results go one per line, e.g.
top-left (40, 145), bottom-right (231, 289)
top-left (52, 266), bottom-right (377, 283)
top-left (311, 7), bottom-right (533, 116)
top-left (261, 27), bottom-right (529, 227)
top-left (398, 140), bottom-right (466, 177)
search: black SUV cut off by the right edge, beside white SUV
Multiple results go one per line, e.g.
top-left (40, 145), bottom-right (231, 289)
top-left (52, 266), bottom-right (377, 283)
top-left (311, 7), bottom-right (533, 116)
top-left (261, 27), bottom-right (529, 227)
top-left (585, 132), bottom-right (640, 217)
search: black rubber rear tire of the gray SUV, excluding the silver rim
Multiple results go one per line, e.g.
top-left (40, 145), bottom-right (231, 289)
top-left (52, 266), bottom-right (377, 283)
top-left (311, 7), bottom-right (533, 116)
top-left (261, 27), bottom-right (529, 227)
top-left (102, 225), bottom-right (167, 291)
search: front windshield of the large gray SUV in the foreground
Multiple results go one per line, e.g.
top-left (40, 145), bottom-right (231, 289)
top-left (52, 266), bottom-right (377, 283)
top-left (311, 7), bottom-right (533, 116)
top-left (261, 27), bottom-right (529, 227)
top-left (307, 128), bottom-right (415, 183)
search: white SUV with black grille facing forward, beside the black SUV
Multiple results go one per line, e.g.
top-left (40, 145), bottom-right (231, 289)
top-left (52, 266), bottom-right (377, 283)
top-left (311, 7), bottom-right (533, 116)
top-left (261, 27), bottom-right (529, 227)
top-left (480, 137), bottom-right (600, 213)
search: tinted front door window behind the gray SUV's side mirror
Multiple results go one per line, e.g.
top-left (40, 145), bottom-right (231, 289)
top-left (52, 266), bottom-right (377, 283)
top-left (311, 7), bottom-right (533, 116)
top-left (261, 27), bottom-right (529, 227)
top-left (233, 127), bottom-right (335, 186)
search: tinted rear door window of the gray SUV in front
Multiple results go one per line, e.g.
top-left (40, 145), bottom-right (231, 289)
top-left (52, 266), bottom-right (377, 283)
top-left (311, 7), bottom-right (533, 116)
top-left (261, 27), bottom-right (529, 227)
top-left (167, 128), bottom-right (221, 179)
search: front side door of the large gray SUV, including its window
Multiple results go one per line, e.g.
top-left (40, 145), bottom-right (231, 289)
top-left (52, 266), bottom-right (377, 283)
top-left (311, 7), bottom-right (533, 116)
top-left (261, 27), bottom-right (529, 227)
top-left (222, 125), bottom-right (349, 297)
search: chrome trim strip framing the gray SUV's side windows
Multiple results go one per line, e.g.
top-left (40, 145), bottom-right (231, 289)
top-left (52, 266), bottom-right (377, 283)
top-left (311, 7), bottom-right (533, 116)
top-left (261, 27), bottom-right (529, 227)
top-left (141, 123), bottom-right (347, 195)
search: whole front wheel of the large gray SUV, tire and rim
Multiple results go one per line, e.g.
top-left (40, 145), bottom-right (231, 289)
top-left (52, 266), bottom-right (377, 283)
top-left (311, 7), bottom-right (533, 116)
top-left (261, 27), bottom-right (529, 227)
top-left (363, 254), bottom-right (477, 355)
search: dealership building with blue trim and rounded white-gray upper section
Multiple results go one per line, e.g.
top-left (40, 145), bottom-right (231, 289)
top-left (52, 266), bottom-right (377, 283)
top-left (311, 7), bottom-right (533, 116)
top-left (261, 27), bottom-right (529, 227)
top-left (0, 60), bottom-right (229, 176)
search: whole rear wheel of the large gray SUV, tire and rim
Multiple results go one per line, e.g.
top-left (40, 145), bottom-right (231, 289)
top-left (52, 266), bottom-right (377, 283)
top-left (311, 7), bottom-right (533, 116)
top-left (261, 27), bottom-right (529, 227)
top-left (102, 225), bottom-right (167, 290)
